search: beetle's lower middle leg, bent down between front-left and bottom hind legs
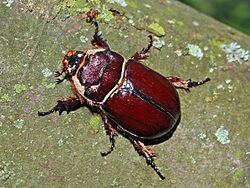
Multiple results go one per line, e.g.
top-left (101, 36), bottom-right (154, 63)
top-left (101, 115), bottom-right (118, 157)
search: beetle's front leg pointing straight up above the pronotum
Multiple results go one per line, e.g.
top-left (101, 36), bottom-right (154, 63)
top-left (91, 21), bottom-right (110, 50)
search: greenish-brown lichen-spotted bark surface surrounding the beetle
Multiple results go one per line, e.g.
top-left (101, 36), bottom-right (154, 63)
top-left (0, 0), bottom-right (250, 187)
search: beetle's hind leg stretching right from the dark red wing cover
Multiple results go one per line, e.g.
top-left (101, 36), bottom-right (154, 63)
top-left (166, 76), bottom-right (210, 92)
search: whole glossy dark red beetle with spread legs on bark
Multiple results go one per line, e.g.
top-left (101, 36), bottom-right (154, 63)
top-left (38, 10), bottom-right (210, 179)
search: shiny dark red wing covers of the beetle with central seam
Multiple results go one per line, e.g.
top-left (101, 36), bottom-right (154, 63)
top-left (103, 60), bottom-right (180, 144)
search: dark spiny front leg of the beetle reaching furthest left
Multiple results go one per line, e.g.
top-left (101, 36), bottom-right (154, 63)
top-left (38, 97), bottom-right (83, 116)
